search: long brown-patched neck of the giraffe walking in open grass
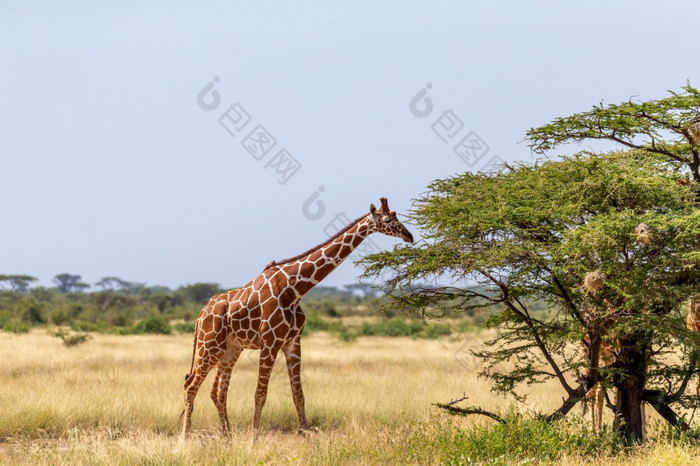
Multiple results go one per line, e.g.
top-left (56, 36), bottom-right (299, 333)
top-left (279, 217), bottom-right (372, 300)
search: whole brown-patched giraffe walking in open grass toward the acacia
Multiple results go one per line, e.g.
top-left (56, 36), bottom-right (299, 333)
top-left (182, 198), bottom-right (413, 441)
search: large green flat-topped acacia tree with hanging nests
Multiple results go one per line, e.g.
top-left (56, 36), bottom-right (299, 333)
top-left (363, 87), bottom-right (700, 439)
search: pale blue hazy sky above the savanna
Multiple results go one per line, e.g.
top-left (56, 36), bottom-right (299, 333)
top-left (0, 1), bottom-right (700, 287)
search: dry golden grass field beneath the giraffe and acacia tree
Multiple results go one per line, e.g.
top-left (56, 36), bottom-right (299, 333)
top-left (0, 329), bottom-right (700, 464)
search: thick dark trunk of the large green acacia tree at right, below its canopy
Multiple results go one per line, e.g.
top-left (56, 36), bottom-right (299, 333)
top-left (613, 335), bottom-right (649, 441)
